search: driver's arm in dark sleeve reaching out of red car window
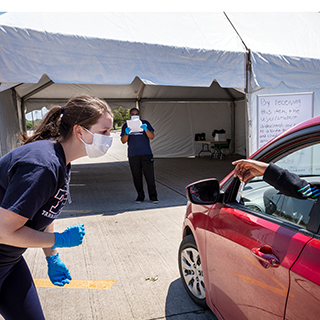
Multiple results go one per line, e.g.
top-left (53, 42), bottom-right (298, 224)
top-left (232, 160), bottom-right (320, 200)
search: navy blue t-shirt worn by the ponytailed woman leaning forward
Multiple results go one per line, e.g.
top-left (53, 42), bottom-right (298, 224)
top-left (0, 140), bottom-right (70, 265)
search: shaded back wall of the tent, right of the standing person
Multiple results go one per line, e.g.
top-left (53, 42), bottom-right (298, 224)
top-left (140, 101), bottom-right (233, 158)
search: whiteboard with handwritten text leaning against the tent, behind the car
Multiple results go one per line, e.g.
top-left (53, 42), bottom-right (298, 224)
top-left (257, 92), bottom-right (313, 148)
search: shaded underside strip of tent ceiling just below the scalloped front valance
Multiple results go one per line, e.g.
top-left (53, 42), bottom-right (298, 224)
top-left (15, 75), bottom-right (244, 112)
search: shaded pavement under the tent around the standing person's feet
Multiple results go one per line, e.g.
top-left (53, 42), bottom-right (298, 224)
top-left (60, 155), bottom-right (244, 218)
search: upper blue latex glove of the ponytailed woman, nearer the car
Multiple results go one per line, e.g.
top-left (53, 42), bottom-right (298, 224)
top-left (51, 224), bottom-right (85, 249)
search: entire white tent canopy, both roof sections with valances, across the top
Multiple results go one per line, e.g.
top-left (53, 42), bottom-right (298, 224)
top-left (0, 12), bottom-right (320, 90)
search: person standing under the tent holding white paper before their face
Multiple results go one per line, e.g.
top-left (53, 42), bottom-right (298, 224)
top-left (121, 108), bottom-right (158, 203)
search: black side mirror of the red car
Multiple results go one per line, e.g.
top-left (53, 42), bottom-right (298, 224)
top-left (186, 179), bottom-right (220, 205)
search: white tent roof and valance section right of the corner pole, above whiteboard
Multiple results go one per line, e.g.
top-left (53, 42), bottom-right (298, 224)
top-left (228, 12), bottom-right (320, 89)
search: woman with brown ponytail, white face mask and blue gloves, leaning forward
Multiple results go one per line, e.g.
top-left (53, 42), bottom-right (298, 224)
top-left (0, 96), bottom-right (113, 320)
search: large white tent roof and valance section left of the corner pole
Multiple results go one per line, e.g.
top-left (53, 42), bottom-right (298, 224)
top-left (0, 13), bottom-right (245, 89)
